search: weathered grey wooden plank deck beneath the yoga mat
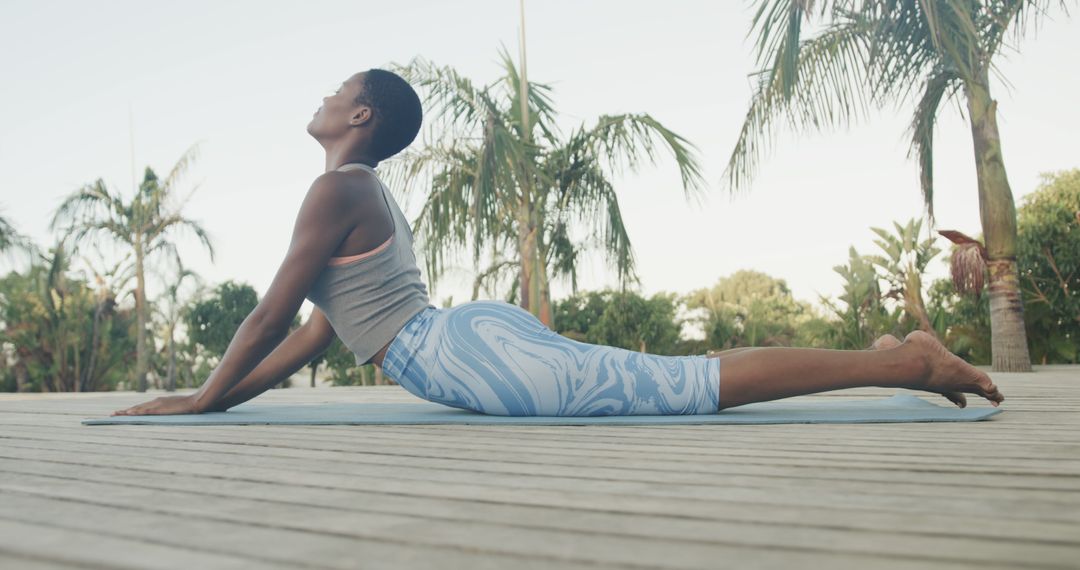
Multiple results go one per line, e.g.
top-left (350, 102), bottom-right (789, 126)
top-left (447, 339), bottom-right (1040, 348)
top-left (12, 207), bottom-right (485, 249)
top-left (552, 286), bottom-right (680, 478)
top-left (0, 366), bottom-right (1080, 570)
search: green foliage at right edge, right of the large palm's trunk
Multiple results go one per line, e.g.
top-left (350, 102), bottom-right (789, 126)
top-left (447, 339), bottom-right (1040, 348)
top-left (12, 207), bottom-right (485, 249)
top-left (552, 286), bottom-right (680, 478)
top-left (1016, 169), bottom-right (1080, 364)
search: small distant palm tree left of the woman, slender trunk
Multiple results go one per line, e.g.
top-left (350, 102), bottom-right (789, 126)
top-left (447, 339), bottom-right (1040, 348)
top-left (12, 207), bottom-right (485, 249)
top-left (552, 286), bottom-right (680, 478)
top-left (50, 147), bottom-right (214, 392)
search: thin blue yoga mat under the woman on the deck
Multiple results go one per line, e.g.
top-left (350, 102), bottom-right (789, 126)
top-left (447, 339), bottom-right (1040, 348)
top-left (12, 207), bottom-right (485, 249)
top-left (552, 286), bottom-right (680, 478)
top-left (82, 394), bottom-right (1002, 425)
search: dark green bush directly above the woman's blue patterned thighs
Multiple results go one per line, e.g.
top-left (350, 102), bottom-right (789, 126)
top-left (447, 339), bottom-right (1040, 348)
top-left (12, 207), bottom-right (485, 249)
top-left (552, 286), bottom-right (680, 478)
top-left (554, 290), bottom-right (681, 354)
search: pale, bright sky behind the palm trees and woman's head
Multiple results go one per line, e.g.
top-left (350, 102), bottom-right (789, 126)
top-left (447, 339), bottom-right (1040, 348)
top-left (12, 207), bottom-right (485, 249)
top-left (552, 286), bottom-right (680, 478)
top-left (0, 0), bottom-right (1080, 314)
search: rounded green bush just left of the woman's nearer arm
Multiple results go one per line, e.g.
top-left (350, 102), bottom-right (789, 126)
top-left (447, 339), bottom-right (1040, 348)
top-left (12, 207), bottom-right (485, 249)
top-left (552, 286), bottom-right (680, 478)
top-left (184, 281), bottom-right (259, 358)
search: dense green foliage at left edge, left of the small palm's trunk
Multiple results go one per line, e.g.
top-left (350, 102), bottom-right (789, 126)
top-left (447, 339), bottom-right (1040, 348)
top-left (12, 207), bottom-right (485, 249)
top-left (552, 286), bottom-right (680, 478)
top-left (0, 244), bottom-right (135, 392)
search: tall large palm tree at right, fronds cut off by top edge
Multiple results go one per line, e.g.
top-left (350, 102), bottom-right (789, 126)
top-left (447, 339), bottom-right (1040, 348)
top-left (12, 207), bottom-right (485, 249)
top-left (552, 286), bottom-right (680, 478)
top-left (726, 0), bottom-right (1066, 370)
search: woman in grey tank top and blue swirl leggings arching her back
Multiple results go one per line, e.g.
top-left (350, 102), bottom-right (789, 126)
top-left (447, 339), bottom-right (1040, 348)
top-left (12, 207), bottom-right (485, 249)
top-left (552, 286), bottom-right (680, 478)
top-left (113, 69), bottom-right (1004, 416)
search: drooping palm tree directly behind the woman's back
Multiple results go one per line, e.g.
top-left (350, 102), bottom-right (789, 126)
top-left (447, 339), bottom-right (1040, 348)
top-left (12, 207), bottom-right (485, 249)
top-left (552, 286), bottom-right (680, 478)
top-left (392, 50), bottom-right (703, 326)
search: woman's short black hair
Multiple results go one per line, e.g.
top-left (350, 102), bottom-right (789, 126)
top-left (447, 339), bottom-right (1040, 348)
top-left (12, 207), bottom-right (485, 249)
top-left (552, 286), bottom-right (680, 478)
top-left (353, 69), bottom-right (423, 160)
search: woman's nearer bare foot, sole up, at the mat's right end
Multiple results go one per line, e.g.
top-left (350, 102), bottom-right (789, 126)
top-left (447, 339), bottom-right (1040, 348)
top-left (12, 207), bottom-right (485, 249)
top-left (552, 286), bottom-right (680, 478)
top-left (903, 330), bottom-right (1005, 408)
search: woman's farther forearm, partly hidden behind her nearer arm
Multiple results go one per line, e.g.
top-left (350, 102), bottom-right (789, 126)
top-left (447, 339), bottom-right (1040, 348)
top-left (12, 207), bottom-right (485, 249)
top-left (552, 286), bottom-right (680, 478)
top-left (206, 308), bottom-right (336, 411)
